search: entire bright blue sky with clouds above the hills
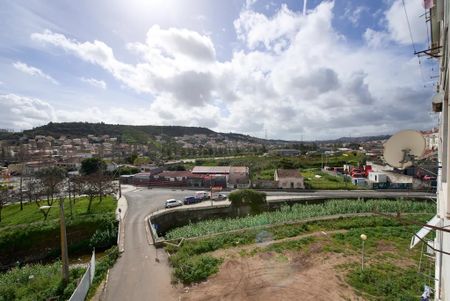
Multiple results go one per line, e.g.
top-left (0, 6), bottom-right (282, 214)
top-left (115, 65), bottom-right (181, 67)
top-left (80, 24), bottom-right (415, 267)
top-left (0, 0), bottom-right (438, 140)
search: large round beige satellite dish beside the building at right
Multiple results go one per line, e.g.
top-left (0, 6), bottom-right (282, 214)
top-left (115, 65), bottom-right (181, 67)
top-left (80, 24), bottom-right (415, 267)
top-left (383, 130), bottom-right (425, 169)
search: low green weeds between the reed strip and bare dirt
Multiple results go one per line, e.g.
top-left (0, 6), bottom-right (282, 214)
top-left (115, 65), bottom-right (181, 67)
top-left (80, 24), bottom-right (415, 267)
top-left (166, 214), bottom-right (432, 286)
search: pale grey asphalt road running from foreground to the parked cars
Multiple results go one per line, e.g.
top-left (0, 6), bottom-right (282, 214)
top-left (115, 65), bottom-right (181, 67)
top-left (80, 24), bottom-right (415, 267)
top-left (105, 188), bottom-right (190, 301)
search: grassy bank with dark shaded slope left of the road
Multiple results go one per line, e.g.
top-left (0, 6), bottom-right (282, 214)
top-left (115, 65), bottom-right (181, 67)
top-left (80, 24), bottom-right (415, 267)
top-left (0, 197), bottom-right (117, 269)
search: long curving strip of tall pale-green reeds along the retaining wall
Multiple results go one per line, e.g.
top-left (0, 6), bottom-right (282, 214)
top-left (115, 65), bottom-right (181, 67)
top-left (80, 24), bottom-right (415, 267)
top-left (166, 200), bottom-right (436, 239)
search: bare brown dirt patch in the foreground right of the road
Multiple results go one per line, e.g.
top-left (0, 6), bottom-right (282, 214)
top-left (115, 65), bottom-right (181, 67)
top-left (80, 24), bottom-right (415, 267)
top-left (180, 252), bottom-right (363, 301)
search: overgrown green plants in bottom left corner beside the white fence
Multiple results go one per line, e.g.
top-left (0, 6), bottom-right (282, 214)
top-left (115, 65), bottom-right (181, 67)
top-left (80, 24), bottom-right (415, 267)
top-left (0, 262), bottom-right (84, 301)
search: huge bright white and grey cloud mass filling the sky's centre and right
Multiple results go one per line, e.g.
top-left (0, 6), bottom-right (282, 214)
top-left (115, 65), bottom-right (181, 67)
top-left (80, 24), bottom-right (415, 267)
top-left (32, 1), bottom-right (432, 139)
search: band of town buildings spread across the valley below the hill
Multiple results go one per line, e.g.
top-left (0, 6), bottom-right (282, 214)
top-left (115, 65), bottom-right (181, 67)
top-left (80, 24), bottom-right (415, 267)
top-left (0, 129), bottom-right (438, 189)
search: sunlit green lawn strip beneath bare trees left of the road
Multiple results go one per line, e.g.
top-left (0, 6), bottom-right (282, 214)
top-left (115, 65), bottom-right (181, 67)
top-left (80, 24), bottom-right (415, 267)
top-left (0, 196), bottom-right (117, 229)
